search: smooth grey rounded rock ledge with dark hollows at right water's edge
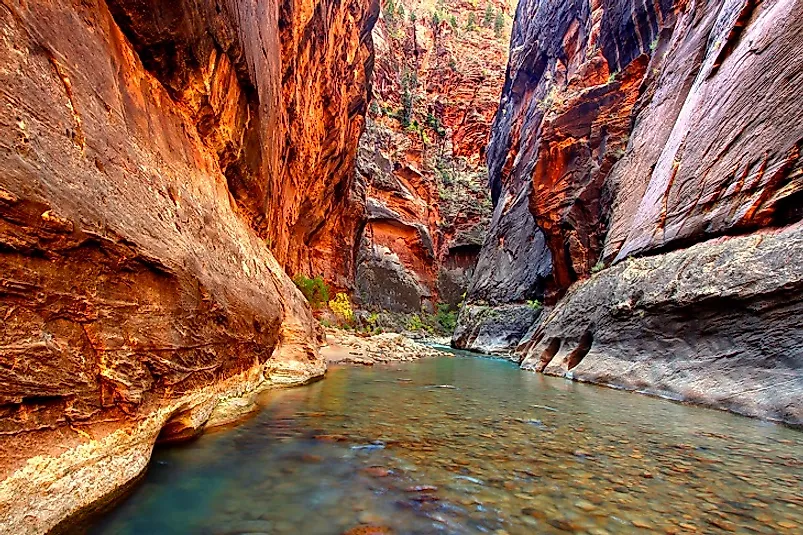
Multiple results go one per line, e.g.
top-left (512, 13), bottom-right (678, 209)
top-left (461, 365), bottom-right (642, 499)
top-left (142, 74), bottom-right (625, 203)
top-left (520, 224), bottom-right (803, 425)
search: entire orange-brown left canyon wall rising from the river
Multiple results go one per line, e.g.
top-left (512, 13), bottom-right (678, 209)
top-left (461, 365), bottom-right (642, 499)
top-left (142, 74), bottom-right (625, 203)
top-left (0, 0), bottom-right (378, 534)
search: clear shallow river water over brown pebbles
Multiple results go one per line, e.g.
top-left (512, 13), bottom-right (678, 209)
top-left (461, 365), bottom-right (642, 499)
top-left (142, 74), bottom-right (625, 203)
top-left (90, 357), bottom-right (803, 535)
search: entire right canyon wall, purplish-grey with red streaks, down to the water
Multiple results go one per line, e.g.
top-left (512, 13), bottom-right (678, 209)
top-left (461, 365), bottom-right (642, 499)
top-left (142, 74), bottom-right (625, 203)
top-left (456, 0), bottom-right (803, 424)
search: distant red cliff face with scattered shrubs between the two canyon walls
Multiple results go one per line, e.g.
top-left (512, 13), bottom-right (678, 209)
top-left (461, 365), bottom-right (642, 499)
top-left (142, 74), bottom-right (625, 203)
top-left (355, 0), bottom-right (512, 313)
